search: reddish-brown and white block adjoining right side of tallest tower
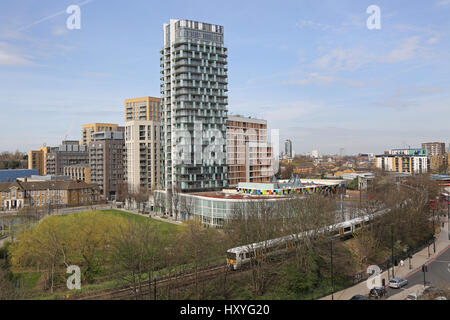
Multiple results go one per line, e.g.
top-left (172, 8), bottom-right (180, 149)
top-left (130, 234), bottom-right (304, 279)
top-left (227, 116), bottom-right (273, 186)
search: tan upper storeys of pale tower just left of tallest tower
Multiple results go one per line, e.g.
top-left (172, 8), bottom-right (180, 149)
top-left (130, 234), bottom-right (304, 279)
top-left (125, 97), bottom-right (161, 121)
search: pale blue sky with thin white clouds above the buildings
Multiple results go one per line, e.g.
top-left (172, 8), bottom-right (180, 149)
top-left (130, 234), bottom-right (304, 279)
top-left (0, 0), bottom-right (450, 154)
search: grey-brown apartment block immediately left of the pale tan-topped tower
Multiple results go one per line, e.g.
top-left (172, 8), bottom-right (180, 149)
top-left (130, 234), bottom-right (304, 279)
top-left (89, 127), bottom-right (125, 200)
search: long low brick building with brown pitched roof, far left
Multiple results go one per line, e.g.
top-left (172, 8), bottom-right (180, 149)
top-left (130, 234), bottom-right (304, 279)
top-left (0, 180), bottom-right (100, 210)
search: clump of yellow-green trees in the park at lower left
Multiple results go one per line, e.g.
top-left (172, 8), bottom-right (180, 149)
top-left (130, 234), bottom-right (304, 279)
top-left (0, 210), bottom-right (192, 299)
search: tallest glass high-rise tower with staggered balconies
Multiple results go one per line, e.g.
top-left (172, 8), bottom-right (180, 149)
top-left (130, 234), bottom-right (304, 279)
top-left (161, 19), bottom-right (228, 191)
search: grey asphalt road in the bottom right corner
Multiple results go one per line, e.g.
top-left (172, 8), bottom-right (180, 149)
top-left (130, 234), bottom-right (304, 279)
top-left (387, 248), bottom-right (450, 296)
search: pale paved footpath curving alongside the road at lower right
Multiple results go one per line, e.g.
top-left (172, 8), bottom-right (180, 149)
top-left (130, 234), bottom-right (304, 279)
top-left (320, 223), bottom-right (450, 300)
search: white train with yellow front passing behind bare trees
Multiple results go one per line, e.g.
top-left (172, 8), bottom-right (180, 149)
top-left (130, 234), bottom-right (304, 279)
top-left (226, 209), bottom-right (388, 270)
